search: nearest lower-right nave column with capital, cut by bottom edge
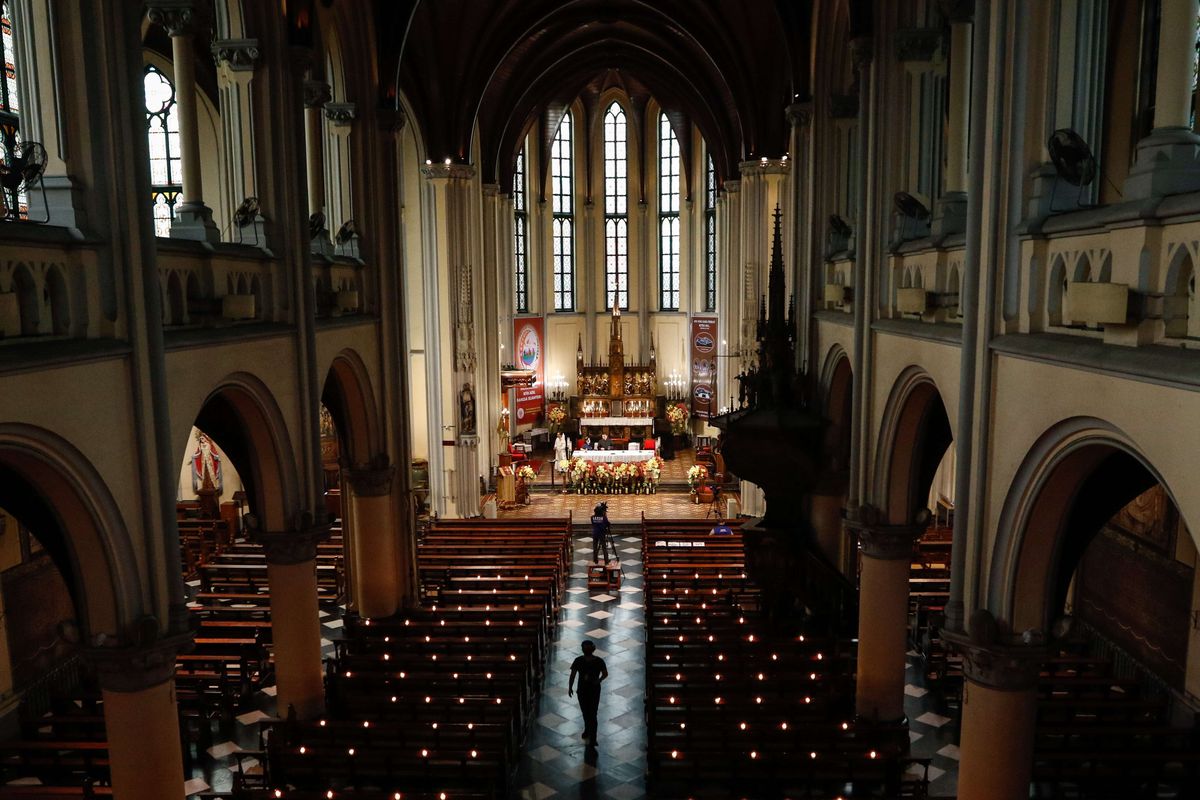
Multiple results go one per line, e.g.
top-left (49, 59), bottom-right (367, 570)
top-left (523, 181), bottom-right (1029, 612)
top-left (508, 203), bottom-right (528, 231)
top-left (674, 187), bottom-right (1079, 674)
top-left (942, 610), bottom-right (1046, 800)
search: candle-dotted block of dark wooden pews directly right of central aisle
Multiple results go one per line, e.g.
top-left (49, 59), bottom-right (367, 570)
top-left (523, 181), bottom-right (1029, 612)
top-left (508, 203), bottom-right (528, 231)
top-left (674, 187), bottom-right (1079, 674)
top-left (642, 519), bottom-right (929, 798)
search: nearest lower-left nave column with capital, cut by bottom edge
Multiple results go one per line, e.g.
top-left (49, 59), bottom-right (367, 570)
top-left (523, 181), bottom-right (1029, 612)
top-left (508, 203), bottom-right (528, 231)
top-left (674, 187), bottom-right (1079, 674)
top-left (84, 633), bottom-right (192, 800)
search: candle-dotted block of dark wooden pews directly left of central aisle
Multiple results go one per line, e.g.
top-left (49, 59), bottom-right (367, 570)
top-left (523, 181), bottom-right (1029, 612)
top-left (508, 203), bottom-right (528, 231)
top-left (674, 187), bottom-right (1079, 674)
top-left (262, 518), bottom-right (571, 799)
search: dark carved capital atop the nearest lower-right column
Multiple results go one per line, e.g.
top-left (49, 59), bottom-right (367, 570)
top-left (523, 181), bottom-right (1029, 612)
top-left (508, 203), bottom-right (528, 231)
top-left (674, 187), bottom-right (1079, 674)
top-left (942, 610), bottom-right (1049, 692)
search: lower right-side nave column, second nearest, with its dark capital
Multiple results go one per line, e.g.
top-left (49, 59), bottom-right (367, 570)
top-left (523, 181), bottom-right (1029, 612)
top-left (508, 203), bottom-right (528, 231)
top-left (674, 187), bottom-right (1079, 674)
top-left (846, 505), bottom-right (929, 722)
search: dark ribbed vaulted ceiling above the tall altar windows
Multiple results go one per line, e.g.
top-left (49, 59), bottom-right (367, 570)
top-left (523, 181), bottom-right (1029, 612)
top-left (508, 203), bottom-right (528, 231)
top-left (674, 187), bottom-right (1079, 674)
top-left (376, 0), bottom-right (811, 186)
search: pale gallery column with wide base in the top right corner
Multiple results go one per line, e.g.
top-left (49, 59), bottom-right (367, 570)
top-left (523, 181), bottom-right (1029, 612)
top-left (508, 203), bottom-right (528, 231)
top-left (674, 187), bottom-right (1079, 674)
top-left (1123, 0), bottom-right (1200, 199)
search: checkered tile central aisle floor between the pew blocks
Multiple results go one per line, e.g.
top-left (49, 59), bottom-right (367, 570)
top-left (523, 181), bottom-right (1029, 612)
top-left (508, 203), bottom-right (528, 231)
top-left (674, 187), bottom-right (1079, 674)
top-left (516, 529), bottom-right (646, 800)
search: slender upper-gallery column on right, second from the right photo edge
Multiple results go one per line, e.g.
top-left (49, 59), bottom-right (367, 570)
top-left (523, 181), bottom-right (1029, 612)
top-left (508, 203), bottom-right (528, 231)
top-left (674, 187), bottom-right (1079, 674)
top-left (930, 0), bottom-right (974, 241)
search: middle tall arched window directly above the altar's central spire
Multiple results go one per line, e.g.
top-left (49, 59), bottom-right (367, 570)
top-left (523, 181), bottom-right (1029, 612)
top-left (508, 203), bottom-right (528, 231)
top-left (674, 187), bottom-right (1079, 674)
top-left (604, 102), bottom-right (629, 309)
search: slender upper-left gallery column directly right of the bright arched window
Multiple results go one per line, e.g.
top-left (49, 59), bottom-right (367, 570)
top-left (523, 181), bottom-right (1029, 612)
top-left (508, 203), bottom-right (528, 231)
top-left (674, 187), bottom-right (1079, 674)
top-left (146, 0), bottom-right (221, 242)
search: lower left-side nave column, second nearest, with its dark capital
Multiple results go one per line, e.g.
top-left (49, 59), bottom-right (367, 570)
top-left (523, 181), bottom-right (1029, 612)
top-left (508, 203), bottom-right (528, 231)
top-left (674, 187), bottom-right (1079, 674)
top-left (251, 525), bottom-right (329, 720)
